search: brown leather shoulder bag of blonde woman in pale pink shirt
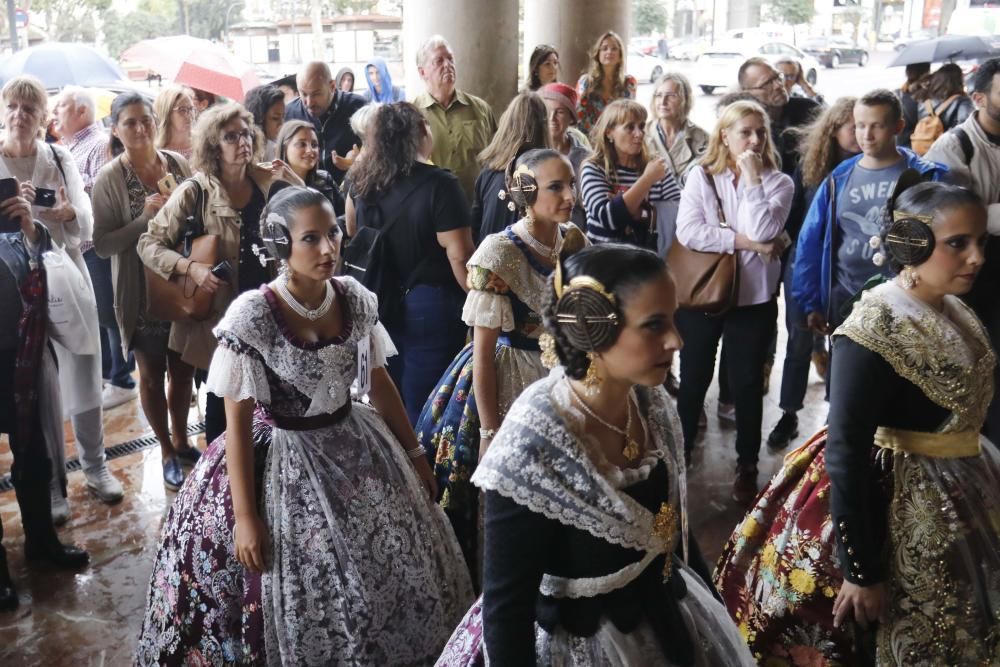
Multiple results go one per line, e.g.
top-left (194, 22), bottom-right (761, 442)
top-left (667, 173), bottom-right (739, 315)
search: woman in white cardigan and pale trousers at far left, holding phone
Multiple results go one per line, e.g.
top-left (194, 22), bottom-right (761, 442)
top-left (0, 76), bottom-right (122, 520)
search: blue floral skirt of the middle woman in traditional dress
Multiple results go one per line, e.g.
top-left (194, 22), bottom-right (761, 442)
top-left (415, 339), bottom-right (547, 580)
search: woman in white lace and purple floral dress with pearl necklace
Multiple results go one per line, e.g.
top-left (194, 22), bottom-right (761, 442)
top-left (136, 187), bottom-right (472, 665)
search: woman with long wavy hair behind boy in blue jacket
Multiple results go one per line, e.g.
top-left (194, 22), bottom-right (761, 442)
top-left (767, 97), bottom-right (861, 450)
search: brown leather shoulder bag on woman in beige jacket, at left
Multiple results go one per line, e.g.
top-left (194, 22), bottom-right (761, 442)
top-left (143, 179), bottom-right (220, 322)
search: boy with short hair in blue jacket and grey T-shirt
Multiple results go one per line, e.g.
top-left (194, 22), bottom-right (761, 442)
top-left (792, 89), bottom-right (948, 334)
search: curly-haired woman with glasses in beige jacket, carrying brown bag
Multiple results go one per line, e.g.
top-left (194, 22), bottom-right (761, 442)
top-left (136, 102), bottom-right (302, 443)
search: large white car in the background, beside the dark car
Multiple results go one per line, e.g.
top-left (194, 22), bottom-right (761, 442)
top-left (691, 40), bottom-right (820, 95)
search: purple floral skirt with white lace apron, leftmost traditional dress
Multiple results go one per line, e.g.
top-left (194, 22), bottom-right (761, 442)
top-left (136, 404), bottom-right (472, 665)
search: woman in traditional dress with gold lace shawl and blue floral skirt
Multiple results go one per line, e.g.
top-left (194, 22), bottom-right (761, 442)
top-left (416, 149), bottom-right (588, 580)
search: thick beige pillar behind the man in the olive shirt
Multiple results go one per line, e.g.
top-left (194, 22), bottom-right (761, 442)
top-left (403, 0), bottom-right (520, 117)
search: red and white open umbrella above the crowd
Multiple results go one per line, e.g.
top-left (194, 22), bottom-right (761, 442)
top-left (121, 35), bottom-right (260, 102)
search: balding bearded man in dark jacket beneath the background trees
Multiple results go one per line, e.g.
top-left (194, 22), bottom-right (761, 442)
top-left (285, 62), bottom-right (365, 185)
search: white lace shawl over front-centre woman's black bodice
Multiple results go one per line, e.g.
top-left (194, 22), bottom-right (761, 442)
top-left (472, 367), bottom-right (687, 556)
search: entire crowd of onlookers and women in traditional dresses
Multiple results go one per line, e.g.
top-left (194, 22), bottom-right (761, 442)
top-left (0, 32), bottom-right (1000, 665)
